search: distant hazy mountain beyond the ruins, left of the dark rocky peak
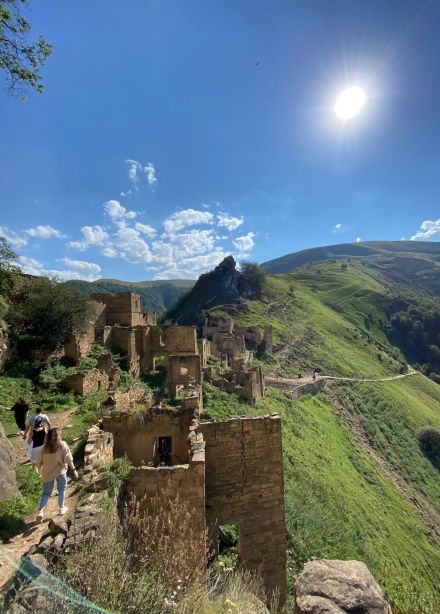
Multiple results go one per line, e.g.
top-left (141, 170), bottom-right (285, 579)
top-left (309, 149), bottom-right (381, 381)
top-left (65, 279), bottom-right (195, 313)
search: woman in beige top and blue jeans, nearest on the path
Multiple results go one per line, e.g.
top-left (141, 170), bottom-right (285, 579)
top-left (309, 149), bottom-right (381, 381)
top-left (36, 428), bottom-right (78, 523)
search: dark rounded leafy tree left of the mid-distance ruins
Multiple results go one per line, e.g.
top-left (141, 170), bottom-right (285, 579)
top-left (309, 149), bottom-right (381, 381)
top-left (10, 277), bottom-right (91, 350)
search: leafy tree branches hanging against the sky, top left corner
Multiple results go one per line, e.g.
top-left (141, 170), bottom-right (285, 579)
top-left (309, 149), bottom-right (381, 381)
top-left (0, 0), bottom-right (52, 94)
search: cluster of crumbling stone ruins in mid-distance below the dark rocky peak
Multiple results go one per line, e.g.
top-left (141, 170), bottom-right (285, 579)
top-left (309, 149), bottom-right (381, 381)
top-left (62, 292), bottom-right (272, 405)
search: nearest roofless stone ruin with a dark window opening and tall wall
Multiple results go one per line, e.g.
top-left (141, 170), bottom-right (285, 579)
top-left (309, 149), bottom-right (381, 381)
top-left (102, 396), bottom-right (286, 603)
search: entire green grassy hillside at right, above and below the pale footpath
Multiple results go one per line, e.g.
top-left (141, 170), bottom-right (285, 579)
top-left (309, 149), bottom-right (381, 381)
top-left (198, 259), bottom-right (440, 614)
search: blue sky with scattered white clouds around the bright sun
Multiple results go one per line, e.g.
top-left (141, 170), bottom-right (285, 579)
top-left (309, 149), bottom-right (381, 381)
top-left (0, 0), bottom-right (440, 280)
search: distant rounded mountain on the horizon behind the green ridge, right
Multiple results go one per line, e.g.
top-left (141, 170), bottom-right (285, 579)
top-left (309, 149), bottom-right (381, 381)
top-left (261, 241), bottom-right (440, 296)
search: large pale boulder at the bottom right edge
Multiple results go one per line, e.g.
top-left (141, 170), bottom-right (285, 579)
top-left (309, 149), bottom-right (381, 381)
top-left (295, 559), bottom-right (391, 614)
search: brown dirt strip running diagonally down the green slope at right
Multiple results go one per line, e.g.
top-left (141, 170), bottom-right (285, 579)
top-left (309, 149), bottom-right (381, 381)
top-left (325, 388), bottom-right (440, 546)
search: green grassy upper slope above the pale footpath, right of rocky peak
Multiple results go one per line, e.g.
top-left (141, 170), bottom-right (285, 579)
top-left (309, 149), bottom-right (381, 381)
top-left (234, 263), bottom-right (404, 377)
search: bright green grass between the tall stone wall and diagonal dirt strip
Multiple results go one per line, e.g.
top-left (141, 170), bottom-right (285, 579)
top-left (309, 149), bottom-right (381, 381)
top-left (205, 390), bottom-right (440, 614)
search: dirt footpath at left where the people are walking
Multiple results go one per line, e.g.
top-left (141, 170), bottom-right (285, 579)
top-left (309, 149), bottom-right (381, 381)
top-left (0, 407), bottom-right (77, 587)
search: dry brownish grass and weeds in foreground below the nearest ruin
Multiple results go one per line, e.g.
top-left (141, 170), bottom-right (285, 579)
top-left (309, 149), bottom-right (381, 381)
top-left (55, 498), bottom-right (265, 614)
